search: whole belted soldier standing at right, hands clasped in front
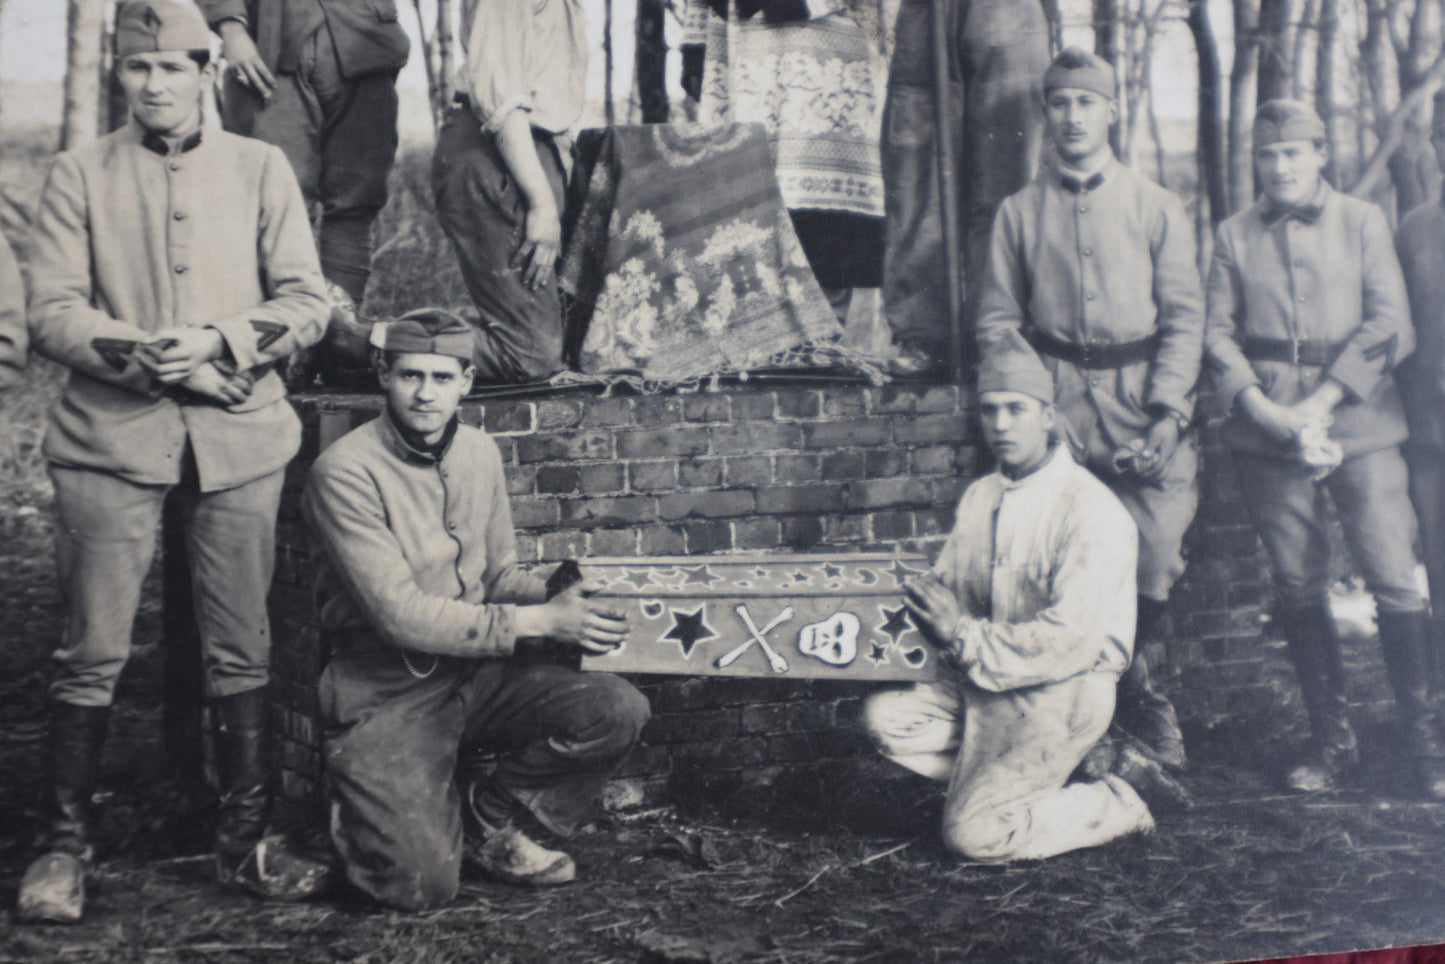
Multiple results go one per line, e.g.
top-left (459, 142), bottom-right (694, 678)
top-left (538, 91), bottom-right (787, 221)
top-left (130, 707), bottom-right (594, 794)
top-left (1205, 100), bottom-right (1445, 798)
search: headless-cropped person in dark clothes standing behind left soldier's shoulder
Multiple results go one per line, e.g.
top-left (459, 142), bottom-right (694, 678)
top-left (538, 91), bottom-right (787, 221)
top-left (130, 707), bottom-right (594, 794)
top-left (197, 0), bottom-right (410, 382)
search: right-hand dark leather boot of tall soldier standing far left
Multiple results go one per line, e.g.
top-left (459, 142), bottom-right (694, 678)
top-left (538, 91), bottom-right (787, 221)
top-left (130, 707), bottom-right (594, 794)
top-left (211, 688), bottom-right (270, 883)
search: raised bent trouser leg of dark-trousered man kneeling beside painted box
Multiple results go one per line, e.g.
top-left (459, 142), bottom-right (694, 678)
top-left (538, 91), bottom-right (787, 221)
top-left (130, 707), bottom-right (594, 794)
top-left (465, 663), bottom-right (650, 837)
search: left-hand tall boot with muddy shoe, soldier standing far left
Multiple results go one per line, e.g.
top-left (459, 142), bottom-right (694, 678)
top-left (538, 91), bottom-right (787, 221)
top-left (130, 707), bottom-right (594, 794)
top-left (16, 700), bottom-right (110, 924)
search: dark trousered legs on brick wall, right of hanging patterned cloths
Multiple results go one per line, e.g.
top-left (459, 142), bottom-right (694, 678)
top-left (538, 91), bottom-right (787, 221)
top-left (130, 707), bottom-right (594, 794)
top-left (881, 0), bottom-right (1049, 374)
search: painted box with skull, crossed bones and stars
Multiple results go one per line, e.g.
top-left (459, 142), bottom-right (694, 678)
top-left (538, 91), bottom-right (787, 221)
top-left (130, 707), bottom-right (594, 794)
top-left (582, 554), bottom-right (938, 681)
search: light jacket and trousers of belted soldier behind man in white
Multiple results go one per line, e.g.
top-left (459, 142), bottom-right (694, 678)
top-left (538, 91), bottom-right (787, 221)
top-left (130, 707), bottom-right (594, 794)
top-left (978, 159), bottom-right (1204, 600)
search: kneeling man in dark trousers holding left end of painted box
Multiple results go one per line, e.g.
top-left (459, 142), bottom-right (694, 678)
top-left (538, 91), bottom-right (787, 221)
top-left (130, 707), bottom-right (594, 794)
top-left (303, 308), bottom-right (649, 909)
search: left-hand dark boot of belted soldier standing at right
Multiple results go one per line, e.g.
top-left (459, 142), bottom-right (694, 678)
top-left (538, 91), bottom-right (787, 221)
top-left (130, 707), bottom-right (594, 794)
top-left (1277, 601), bottom-right (1360, 792)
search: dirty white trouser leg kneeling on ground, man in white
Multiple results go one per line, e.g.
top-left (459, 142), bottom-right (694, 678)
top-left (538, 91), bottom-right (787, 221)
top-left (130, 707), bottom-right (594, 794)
top-left (944, 673), bottom-right (1153, 861)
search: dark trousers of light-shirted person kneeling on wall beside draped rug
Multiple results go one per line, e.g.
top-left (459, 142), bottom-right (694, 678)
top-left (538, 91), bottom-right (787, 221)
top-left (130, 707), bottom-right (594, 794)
top-left (432, 108), bottom-right (565, 384)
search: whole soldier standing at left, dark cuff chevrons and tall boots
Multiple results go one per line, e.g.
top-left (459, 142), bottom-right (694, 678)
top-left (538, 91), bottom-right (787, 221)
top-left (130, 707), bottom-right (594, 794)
top-left (19, 0), bottom-right (327, 921)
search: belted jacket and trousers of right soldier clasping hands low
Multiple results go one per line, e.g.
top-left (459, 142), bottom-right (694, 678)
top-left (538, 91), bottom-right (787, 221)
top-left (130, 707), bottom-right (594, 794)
top-left (1205, 182), bottom-right (1425, 613)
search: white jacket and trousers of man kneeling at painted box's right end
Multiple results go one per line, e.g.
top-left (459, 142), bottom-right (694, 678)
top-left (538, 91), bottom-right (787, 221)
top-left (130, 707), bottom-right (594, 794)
top-left (867, 447), bottom-right (1153, 860)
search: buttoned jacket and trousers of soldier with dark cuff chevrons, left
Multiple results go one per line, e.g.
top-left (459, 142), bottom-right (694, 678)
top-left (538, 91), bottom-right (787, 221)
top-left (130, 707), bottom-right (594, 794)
top-left (27, 121), bottom-right (327, 705)
